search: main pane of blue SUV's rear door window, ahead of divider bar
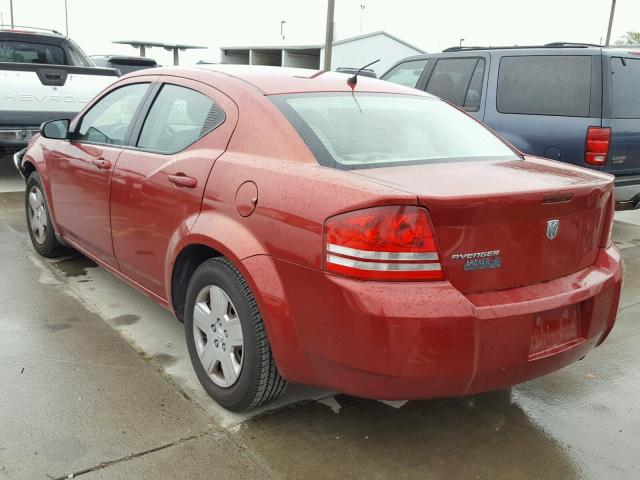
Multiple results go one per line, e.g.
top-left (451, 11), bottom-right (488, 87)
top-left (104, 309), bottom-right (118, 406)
top-left (427, 58), bottom-right (478, 107)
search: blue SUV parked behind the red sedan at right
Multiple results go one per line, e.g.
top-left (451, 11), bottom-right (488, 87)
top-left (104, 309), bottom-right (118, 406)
top-left (380, 43), bottom-right (640, 210)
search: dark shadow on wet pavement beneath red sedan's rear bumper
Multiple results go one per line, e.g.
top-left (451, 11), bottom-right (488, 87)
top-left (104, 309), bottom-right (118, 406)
top-left (237, 389), bottom-right (580, 479)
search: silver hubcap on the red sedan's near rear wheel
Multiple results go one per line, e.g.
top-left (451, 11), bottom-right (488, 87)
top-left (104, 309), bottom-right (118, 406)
top-left (193, 285), bottom-right (244, 388)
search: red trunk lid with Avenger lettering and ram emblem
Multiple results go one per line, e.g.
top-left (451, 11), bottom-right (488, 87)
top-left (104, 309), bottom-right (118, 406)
top-left (355, 158), bottom-right (613, 293)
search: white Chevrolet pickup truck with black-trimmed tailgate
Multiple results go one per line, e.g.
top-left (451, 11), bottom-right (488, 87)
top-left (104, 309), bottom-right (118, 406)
top-left (0, 29), bottom-right (117, 147)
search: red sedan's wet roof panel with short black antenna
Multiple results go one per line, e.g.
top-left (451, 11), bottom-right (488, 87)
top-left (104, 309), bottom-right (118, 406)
top-left (142, 64), bottom-right (430, 96)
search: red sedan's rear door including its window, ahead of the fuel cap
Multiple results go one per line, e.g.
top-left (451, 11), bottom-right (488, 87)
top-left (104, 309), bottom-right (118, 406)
top-left (111, 78), bottom-right (238, 298)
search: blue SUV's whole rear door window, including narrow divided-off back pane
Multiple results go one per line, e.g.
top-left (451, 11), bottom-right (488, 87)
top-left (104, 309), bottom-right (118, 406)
top-left (427, 58), bottom-right (485, 112)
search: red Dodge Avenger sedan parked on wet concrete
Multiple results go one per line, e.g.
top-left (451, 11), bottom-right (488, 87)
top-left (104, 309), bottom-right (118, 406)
top-left (16, 66), bottom-right (622, 410)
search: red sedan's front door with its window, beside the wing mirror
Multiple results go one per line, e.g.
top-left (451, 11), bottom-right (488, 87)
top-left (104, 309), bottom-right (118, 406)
top-left (45, 82), bottom-right (150, 268)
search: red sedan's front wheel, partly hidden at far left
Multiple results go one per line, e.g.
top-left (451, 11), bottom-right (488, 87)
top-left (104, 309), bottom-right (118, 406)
top-left (24, 172), bottom-right (68, 258)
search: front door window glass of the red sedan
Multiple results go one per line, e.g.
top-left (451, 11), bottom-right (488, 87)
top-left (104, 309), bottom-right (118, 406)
top-left (77, 83), bottom-right (149, 145)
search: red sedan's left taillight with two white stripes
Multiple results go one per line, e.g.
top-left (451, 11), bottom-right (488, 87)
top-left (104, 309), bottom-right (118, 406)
top-left (324, 206), bottom-right (444, 280)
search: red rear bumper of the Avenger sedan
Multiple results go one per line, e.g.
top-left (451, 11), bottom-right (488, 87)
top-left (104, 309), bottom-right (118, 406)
top-left (243, 247), bottom-right (622, 399)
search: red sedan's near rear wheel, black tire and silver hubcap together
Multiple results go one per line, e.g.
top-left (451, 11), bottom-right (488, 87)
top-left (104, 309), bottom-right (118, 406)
top-left (184, 258), bottom-right (286, 411)
